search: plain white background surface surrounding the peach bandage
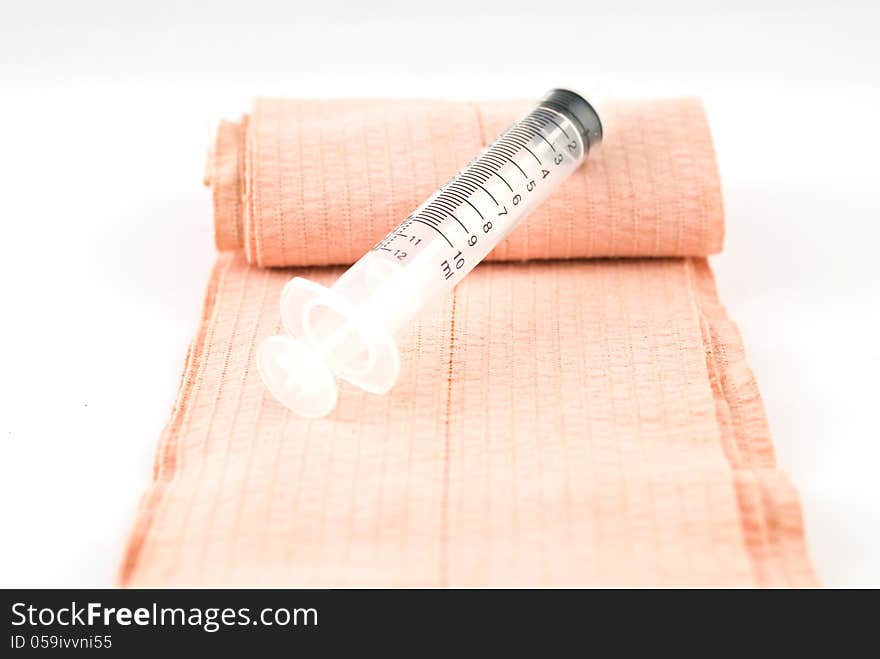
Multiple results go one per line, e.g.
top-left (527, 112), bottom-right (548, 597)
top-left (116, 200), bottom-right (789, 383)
top-left (0, 0), bottom-right (880, 586)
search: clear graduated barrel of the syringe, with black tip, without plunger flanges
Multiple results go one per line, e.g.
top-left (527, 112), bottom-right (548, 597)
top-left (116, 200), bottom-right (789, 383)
top-left (333, 89), bottom-right (602, 334)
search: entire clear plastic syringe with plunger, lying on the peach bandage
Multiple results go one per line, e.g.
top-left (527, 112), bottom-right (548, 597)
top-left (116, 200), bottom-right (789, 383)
top-left (257, 89), bottom-right (602, 417)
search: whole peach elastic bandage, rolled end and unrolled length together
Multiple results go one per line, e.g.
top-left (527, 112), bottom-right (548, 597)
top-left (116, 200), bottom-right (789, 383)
top-left (120, 95), bottom-right (817, 586)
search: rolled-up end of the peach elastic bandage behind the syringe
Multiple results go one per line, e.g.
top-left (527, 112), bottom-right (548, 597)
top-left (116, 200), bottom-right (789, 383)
top-left (210, 99), bottom-right (723, 266)
